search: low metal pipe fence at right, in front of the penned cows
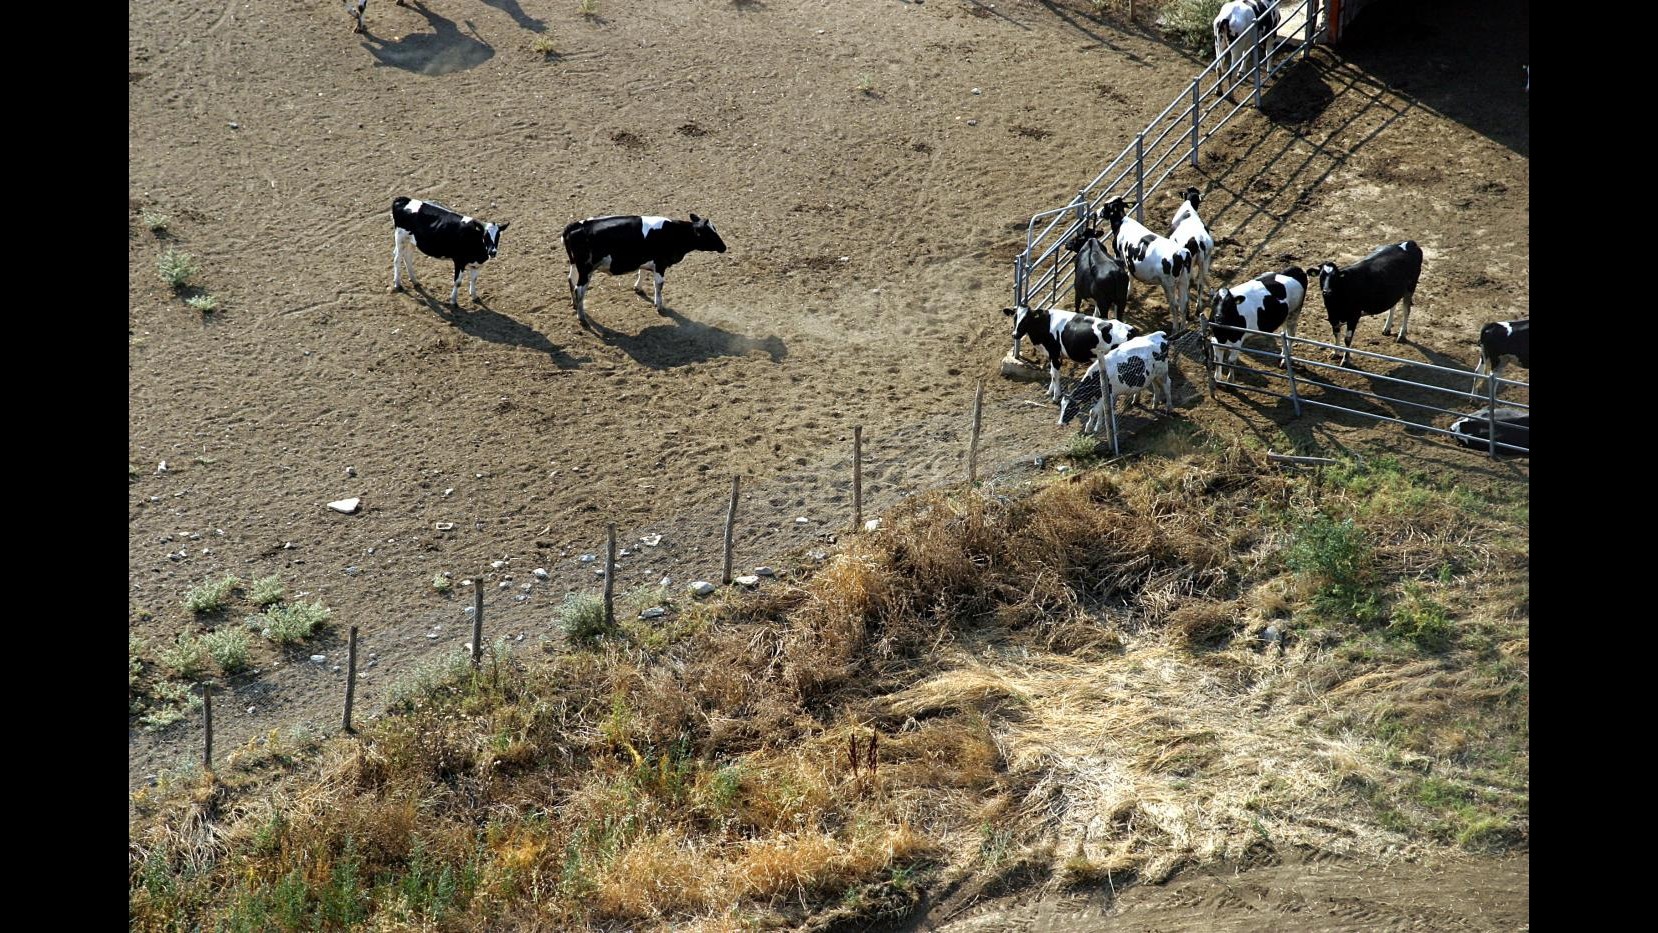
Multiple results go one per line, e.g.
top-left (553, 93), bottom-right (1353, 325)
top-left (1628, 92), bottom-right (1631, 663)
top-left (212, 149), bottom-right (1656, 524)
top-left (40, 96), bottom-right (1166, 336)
top-left (1200, 320), bottom-right (1532, 457)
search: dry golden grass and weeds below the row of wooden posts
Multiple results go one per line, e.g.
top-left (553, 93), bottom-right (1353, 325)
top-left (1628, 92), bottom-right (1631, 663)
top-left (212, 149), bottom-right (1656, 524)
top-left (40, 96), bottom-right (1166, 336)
top-left (129, 437), bottom-right (1529, 930)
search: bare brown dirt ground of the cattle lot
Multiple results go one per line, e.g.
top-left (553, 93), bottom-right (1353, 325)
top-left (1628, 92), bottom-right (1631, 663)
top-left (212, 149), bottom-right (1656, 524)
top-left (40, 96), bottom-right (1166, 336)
top-left (128, 0), bottom-right (1530, 928)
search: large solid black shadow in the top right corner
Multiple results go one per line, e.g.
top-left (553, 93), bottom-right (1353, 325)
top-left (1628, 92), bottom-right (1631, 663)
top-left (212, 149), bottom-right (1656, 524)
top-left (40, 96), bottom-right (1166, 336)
top-left (1336, 0), bottom-right (1532, 157)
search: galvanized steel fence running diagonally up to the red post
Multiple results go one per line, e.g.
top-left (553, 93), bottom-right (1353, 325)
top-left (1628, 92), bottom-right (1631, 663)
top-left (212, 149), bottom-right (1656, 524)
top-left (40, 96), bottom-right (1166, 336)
top-left (1013, 0), bottom-right (1328, 318)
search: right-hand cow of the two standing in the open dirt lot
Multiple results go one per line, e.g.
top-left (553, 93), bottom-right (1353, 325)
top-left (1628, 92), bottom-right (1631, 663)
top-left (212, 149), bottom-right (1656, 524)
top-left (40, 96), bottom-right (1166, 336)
top-left (562, 214), bottom-right (725, 325)
